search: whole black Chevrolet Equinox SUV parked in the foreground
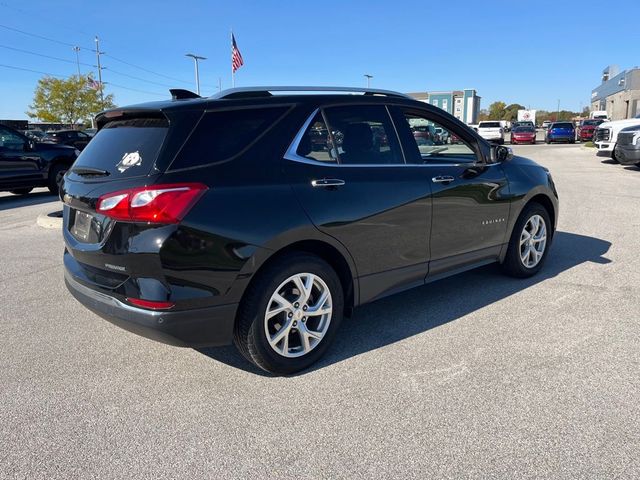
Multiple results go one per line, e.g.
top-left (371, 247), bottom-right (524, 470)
top-left (61, 87), bottom-right (558, 374)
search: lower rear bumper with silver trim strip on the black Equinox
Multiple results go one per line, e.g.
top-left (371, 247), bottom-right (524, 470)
top-left (65, 269), bottom-right (238, 347)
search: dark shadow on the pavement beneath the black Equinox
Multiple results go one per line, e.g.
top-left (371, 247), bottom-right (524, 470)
top-left (199, 231), bottom-right (611, 375)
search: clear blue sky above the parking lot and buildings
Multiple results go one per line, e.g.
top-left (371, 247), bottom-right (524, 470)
top-left (0, 0), bottom-right (640, 119)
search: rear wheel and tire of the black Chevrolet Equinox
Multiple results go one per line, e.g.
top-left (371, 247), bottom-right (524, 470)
top-left (234, 253), bottom-right (344, 375)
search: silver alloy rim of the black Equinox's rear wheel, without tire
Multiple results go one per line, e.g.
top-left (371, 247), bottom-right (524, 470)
top-left (264, 273), bottom-right (333, 358)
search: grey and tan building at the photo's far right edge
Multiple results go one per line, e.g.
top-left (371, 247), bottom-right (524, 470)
top-left (591, 65), bottom-right (640, 120)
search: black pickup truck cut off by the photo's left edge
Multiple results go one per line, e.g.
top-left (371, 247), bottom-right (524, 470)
top-left (0, 125), bottom-right (80, 195)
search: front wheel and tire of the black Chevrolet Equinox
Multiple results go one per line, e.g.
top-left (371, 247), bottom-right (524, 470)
top-left (502, 202), bottom-right (553, 278)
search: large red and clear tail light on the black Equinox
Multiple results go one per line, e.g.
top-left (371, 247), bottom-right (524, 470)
top-left (96, 183), bottom-right (208, 223)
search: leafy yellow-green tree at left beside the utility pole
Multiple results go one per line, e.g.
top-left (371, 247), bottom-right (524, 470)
top-left (27, 75), bottom-right (115, 125)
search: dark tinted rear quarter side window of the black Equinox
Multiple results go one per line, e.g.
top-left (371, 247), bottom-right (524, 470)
top-left (171, 107), bottom-right (288, 170)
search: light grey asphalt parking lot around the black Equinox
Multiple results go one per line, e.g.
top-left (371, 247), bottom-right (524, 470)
top-left (0, 144), bottom-right (640, 479)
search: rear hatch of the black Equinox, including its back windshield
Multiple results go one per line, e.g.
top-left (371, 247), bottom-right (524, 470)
top-left (60, 109), bottom-right (202, 297)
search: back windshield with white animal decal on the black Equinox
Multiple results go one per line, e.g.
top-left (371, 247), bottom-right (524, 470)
top-left (72, 118), bottom-right (169, 180)
